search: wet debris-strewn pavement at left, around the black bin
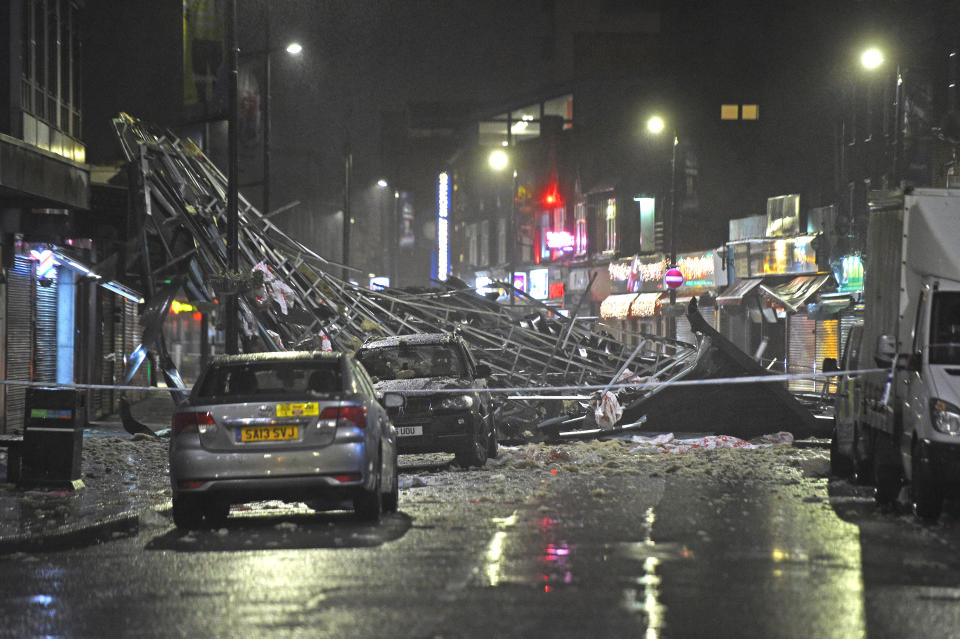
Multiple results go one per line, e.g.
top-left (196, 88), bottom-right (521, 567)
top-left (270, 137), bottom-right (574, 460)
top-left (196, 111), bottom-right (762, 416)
top-left (0, 393), bottom-right (174, 555)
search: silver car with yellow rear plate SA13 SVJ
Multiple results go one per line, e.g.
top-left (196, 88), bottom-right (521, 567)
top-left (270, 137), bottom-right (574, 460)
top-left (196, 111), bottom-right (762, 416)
top-left (170, 352), bottom-right (399, 528)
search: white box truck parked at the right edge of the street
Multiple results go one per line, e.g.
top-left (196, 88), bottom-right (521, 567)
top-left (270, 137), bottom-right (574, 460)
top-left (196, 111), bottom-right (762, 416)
top-left (831, 188), bottom-right (960, 519)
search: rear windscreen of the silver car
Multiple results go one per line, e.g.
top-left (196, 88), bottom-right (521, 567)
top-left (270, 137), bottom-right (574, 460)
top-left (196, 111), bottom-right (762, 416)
top-left (196, 361), bottom-right (344, 401)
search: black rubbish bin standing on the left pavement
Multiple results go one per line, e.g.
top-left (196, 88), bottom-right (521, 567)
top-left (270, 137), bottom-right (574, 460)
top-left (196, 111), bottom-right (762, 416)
top-left (19, 387), bottom-right (86, 485)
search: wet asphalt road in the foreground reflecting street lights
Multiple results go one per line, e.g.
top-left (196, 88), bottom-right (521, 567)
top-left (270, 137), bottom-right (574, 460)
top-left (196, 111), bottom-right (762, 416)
top-left (0, 458), bottom-right (960, 639)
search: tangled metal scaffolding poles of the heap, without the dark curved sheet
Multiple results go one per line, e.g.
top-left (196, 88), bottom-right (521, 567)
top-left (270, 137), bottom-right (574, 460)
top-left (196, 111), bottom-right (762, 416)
top-left (114, 114), bottom-right (696, 436)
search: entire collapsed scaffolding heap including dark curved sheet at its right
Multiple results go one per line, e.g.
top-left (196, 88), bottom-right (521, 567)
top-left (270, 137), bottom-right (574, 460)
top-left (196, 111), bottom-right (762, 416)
top-left (107, 114), bottom-right (813, 442)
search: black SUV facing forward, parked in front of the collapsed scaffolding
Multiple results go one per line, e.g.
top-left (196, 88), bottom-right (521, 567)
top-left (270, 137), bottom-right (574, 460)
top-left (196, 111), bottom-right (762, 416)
top-left (356, 333), bottom-right (498, 467)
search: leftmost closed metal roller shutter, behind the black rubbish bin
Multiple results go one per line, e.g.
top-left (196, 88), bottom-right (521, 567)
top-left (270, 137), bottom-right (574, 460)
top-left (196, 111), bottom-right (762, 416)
top-left (5, 255), bottom-right (34, 431)
